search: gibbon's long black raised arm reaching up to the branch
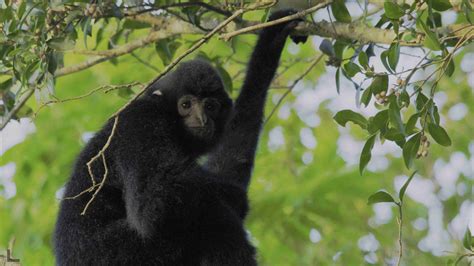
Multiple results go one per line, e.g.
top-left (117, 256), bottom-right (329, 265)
top-left (207, 10), bottom-right (304, 189)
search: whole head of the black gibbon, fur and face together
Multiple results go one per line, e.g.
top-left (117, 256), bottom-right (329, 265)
top-left (149, 60), bottom-right (233, 149)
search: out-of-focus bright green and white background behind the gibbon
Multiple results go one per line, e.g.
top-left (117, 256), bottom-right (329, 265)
top-left (0, 12), bottom-right (474, 265)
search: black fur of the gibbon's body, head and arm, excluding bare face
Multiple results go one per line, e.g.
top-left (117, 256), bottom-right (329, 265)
top-left (54, 11), bottom-right (304, 265)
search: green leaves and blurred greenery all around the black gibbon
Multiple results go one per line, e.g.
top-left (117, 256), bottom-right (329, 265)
top-left (0, 0), bottom-right (474, 265)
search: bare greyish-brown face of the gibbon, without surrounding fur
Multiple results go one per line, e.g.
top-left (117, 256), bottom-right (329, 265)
top-left (177, 94), bottom-right (222, 141)
